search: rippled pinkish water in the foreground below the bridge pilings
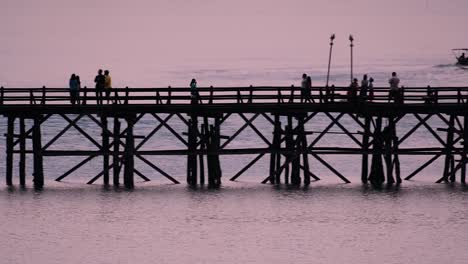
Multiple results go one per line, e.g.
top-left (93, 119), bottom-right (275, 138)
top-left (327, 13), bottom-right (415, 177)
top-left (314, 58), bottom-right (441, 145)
top-left (0, 182), bottom-right (468, 264)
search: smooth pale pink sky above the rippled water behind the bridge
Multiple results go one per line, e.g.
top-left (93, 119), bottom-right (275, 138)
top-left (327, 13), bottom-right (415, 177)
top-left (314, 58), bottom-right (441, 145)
top-left (0, 0), bottom-right (468, 86)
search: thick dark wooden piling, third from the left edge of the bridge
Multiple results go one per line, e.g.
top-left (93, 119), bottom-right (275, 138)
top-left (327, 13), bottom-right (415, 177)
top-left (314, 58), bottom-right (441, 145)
top-left (32, 116), bottom-right (44, 188)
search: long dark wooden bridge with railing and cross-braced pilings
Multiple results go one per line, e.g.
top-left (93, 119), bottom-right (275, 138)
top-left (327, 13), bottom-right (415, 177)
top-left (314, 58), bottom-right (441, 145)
top-left (0, 86), bottom-right (468, 188)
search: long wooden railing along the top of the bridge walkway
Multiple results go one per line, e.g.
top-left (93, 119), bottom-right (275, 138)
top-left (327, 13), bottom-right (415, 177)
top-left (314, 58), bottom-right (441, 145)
top-left (0, 86), bottom-right (468, 105)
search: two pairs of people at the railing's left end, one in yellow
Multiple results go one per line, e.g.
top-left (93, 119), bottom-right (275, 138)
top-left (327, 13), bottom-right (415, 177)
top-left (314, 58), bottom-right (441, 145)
top-left (69, 69), bottom-right (112, 105)
